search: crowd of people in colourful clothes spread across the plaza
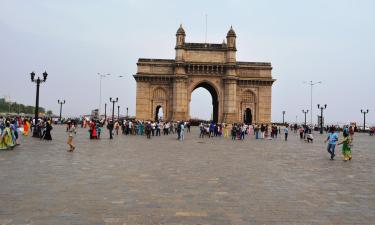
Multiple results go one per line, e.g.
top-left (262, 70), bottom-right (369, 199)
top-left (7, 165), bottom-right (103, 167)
top-left (0, 116), bottom-right (374, 161)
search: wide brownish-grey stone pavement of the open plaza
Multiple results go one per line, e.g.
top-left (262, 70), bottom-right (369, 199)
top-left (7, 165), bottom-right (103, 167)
top-left (0, 126), bottom-right (375, 225)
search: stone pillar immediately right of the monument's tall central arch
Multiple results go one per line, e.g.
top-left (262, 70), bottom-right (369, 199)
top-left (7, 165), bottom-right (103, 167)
top-left (223, 77), bottom-right (238, 123)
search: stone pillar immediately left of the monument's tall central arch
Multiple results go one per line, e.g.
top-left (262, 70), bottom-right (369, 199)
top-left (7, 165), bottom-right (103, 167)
top-left (172, 78), bottom-right (188, 121)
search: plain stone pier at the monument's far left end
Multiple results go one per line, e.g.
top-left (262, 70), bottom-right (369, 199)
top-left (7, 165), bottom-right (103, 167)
top-left (136, 81), bottom-right (152, 120)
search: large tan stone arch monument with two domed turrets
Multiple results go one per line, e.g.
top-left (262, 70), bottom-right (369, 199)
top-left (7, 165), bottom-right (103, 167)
top-left (134, 25), bottom-right (275, 124)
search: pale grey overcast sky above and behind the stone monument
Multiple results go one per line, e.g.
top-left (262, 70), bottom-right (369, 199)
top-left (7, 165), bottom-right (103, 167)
top-left (0, 0), bottom-right (375, 123)
